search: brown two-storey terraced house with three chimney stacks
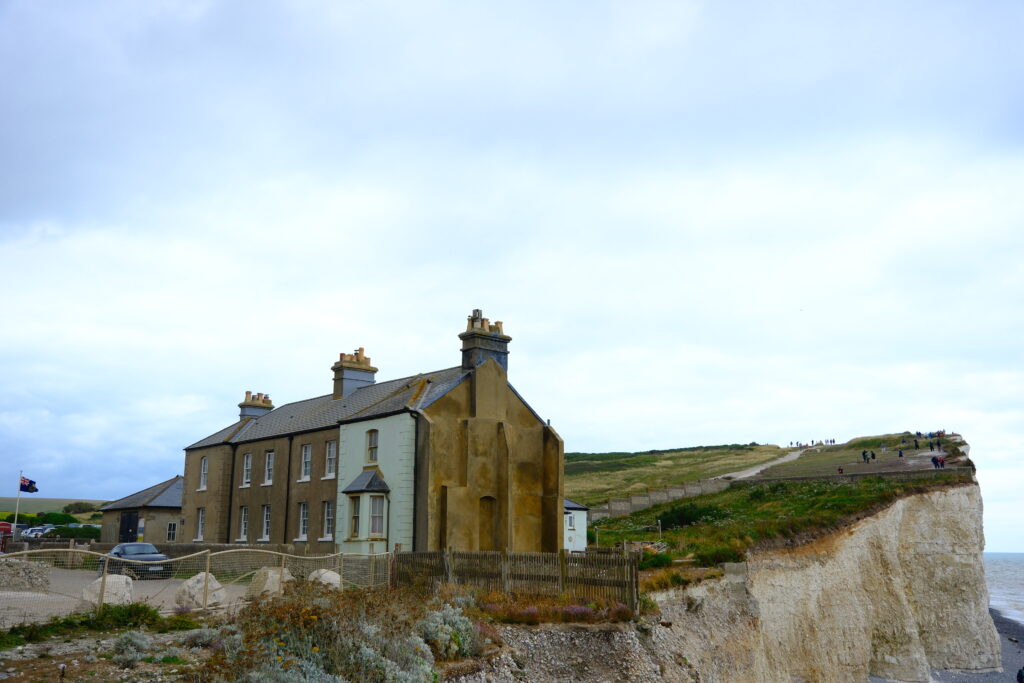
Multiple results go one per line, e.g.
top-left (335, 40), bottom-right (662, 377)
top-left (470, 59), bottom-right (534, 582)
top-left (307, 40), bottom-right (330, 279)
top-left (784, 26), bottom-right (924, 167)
top-left (179, 309), bottom-right (564, 553)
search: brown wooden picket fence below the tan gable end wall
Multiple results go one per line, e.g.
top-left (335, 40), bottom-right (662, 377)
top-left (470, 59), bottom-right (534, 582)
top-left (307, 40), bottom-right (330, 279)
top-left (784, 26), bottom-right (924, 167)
top-left (391, 550), bottom-right (639, 611)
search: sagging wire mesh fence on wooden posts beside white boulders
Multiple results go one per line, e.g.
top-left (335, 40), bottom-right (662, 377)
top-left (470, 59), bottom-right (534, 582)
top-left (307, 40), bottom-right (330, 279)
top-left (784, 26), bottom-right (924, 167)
top-left (0, 549), bottom-right (391, 629)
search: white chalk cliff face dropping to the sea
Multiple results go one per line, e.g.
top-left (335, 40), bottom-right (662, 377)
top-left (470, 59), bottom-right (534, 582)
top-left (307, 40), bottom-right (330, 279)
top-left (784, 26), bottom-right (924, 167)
top-left (458, 485), bottom-right (999, 683)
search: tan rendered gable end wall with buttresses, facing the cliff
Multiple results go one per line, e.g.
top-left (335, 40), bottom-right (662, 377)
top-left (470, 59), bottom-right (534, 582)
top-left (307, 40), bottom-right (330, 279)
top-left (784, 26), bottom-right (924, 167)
top-left (416, 360), bottom-right (564, 552)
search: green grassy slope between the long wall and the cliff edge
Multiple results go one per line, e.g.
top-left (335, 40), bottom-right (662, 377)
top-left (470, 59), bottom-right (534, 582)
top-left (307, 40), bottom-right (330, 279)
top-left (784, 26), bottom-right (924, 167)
top-left (594, 472), bottom-right (963, 566)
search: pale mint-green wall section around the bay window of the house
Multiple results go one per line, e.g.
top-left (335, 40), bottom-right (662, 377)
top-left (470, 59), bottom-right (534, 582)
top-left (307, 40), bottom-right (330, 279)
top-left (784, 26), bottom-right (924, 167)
top-left (336, 413), bottom-right (416, 553)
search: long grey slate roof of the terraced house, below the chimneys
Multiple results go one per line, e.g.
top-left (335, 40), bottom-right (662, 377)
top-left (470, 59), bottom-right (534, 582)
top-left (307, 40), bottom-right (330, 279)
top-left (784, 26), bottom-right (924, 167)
top-left (185, 367), bottom-right (472, 451)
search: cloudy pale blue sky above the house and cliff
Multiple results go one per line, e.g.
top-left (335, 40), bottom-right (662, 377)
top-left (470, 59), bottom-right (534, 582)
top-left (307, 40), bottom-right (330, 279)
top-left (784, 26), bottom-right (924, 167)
top-left (0, 0), bottom-right (1024, 552)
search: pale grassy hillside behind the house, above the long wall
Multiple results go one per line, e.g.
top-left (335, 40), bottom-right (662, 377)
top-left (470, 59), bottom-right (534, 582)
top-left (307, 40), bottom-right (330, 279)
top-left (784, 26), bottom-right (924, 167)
top-left (565, 443), bottom-right (788, 506)
